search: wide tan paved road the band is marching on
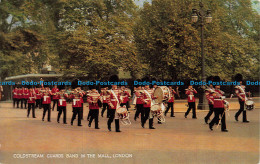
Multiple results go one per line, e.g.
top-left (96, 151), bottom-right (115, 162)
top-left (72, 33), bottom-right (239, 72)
top-left (0, 99), bottom-right (259, 164)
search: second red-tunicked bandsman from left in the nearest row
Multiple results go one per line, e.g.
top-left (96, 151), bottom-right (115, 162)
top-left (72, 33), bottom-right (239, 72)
top-left (42, 87), bottom-right (52, 122)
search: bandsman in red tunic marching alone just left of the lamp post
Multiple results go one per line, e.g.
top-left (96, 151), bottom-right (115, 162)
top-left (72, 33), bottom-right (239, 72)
top-left (184, 85), bottom-right (198, 119)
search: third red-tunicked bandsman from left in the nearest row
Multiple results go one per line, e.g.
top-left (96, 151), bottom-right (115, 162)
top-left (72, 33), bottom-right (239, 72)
top-left (57, 90), bottom-right (68, 124)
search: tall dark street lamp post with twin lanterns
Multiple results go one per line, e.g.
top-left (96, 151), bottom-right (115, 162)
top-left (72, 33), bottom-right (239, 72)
top-left (191, 2), bottom-right (212, 109)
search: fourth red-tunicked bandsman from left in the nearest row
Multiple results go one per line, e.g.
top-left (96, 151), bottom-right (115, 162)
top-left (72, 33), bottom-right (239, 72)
top-left (71, 90), bottom-right (83, 126)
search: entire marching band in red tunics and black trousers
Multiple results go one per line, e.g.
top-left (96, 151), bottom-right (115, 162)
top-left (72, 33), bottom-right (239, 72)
top-left (9, 77), bottom-right (254, 132)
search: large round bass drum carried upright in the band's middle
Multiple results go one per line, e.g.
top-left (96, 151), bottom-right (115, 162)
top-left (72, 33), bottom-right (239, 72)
top-left (154, 86), bottom-right (170, 103)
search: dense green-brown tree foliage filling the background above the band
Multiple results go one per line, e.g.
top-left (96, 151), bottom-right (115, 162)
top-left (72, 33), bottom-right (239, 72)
top-left (0, 0), bottom-right (260, 80)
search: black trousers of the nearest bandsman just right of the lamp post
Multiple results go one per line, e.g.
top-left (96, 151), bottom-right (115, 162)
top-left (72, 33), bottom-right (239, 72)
top-left (209, 108), bottom-right (226, 130)
